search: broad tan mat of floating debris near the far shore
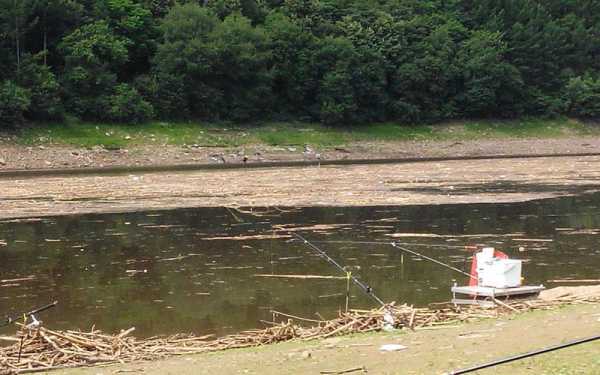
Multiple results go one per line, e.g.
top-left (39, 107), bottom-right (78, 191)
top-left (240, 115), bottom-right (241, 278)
top-left (0, 156), bottom-right (600, 218)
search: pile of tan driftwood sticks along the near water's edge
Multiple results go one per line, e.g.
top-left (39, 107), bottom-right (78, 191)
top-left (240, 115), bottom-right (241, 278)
top-left (0, 296), bottom-right (600, 375)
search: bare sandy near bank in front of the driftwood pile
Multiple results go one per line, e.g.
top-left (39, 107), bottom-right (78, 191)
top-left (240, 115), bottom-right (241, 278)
top-left (56, 304), bottom-right (600, 375)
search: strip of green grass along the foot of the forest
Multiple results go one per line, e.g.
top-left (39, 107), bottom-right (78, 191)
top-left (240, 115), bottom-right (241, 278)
top-left (10, 118), bottom-right (600, 148)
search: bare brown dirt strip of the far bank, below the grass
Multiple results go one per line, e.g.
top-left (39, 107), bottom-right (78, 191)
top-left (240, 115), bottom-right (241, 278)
top-left (0, 136), bottom-right (600, 171)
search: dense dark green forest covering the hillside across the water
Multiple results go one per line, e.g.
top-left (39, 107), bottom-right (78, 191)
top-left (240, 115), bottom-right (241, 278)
top-left (0, 0), bottom-right (600, 128)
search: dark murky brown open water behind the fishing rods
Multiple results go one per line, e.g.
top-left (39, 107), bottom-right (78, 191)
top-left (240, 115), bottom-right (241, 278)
top-left (0, 194), bottom-right (600, 336)
